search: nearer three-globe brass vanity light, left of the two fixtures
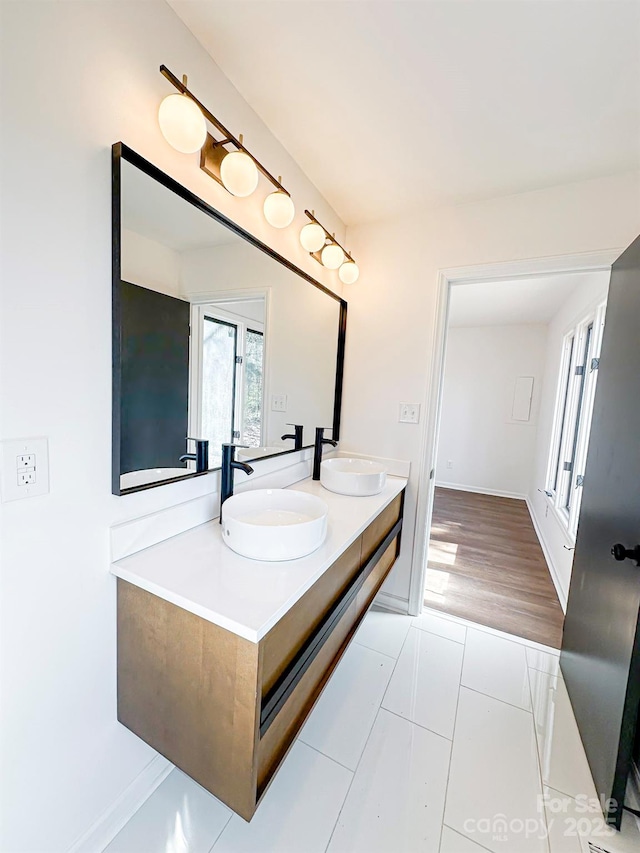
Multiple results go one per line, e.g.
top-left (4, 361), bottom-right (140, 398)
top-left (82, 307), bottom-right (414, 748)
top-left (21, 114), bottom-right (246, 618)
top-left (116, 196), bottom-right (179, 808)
top-left (158, 65), bottom-right (295, 215)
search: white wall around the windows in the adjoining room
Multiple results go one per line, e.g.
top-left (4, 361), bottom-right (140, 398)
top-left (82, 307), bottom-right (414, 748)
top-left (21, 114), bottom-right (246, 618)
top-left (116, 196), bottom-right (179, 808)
top-left (529, 273), bottom-right (609, 608)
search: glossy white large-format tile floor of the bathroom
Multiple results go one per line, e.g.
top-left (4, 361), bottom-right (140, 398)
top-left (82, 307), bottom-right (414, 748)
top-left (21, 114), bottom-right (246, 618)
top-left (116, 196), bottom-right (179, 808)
top-left (107, 611), bottom-right (640, 853)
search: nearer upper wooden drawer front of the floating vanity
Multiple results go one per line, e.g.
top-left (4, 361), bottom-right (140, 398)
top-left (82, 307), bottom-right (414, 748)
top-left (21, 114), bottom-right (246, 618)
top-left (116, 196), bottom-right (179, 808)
top-left (262, 538), bottom-right (361, 696)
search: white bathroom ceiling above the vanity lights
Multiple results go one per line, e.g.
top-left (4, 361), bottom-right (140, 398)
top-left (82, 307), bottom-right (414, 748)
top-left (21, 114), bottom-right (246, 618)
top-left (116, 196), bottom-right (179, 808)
top-left (168, 0), bottom-right (640, 224)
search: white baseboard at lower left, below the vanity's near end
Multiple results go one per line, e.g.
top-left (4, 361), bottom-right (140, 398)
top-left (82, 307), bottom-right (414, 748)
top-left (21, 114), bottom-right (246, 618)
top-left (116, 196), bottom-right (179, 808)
top-left (68, 755), bottom-right (173, 853)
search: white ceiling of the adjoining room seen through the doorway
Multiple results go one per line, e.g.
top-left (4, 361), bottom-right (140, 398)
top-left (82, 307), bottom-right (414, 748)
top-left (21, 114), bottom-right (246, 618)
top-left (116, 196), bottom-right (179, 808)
top-left (449, 272), bottom-right (609, 326)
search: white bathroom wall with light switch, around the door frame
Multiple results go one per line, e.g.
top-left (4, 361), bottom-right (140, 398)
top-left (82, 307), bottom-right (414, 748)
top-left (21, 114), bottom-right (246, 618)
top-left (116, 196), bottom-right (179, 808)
top-left (341, 173), bottom-right (640, 606)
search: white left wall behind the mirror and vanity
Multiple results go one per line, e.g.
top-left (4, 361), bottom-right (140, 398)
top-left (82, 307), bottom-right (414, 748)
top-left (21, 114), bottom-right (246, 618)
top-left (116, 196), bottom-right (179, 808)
top-left (0, 0), bottom-right (344, 853)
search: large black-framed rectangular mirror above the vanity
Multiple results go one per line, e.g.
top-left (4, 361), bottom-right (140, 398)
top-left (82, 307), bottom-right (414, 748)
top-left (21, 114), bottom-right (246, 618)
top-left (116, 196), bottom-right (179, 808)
top-left (113, 143), bottom-right (347, 495)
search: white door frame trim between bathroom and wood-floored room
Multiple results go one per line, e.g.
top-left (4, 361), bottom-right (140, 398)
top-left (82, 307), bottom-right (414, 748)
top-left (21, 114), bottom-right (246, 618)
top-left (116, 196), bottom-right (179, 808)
top-left (409, 248), bottom-right (624, 616)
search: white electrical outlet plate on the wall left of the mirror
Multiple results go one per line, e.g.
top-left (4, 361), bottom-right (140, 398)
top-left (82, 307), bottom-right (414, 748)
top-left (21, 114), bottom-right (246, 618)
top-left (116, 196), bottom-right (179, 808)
top-left (0, 438), bottom-right (49, 503)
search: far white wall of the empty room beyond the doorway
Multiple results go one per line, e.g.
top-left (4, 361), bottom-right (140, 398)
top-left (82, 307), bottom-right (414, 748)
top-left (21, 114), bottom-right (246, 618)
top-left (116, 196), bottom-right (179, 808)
top-left (436, 325), bottom-right (547, 498)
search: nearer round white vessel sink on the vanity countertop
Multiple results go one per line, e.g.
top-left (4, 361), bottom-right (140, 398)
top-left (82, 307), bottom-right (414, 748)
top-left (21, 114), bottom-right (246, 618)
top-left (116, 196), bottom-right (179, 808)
top-left (222, 489), bottom-right (329, 562)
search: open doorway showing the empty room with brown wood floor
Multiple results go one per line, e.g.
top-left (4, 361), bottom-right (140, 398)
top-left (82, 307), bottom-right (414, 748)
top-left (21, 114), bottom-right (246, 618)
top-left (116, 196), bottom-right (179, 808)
top-left (412, 256), bottom-right (610, 648)
